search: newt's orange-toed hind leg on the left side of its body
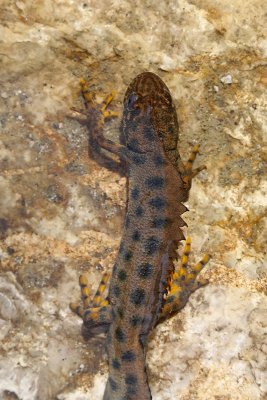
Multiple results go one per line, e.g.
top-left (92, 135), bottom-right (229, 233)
top-left (70, 274), bottom-right (111, 338)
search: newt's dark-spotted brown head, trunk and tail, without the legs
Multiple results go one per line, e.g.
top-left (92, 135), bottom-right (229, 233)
top-left (104, 72), bottom-right (189, 400)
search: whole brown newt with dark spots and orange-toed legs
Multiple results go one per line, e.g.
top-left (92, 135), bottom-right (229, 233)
top-left (71, 72), bottom-right (211, 400)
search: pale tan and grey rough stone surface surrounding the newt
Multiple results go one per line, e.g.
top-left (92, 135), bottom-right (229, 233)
top-left (0, 0), bottom-right (267, 400)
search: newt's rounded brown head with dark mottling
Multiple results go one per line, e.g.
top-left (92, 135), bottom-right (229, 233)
top-left (122, 72), bottom-right (178, 163)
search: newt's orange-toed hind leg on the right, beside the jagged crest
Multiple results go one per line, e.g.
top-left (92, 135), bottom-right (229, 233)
top-left (159, 237), bottom-right (210, 320)
